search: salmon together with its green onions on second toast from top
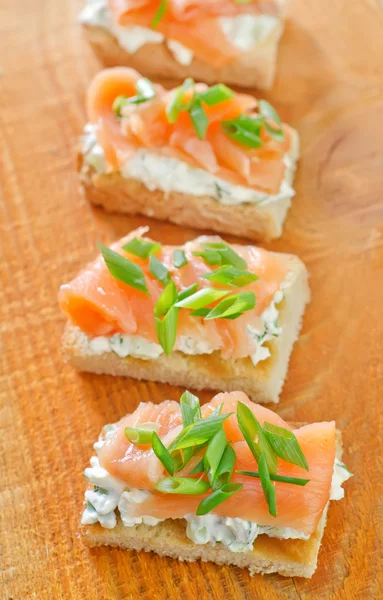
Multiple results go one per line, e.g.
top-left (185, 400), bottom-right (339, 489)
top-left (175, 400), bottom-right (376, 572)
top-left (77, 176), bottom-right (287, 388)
top-left (87, 68), bottom-right (292, 194)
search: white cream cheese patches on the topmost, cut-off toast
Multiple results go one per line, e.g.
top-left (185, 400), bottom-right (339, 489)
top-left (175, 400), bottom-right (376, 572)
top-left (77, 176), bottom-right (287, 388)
top-left (79, 0), bottom-right (282, 66)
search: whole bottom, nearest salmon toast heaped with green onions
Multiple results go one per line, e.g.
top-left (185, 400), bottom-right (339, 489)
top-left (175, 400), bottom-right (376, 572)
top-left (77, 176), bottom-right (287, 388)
top-left (81, 392), bottom-right (351, 577)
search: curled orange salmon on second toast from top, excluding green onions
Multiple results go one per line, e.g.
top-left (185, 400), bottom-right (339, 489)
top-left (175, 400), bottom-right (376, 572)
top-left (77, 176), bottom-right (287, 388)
top-left (87, 67), bottom-right (291, 193)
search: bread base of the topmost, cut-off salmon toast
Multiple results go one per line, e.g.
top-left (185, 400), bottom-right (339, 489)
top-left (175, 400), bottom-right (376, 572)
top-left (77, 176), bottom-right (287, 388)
top-left (83, 19), bottom-right (284, 89)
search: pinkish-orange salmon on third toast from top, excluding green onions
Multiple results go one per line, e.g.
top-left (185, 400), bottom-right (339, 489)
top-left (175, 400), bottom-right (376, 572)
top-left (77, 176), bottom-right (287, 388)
top-left (59, 228), bottom-right (288, 358)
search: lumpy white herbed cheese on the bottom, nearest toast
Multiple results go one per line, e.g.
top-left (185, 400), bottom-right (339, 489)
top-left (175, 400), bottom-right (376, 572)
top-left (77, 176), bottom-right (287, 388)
top-left (81, 432), bottom-right (352, 552)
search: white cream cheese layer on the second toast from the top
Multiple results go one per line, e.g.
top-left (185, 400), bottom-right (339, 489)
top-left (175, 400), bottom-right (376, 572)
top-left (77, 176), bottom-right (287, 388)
top-left (82, 123), bottom-right (299, 206)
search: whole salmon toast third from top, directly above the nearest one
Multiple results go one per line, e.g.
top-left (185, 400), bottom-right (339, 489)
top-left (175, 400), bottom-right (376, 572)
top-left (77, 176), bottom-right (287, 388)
top-left (59, 228), bottom-right (309, 402)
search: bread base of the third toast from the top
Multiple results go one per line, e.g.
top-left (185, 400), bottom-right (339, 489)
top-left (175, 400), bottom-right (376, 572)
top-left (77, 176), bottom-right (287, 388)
top-left (62, 255), bottom-right (310, 403)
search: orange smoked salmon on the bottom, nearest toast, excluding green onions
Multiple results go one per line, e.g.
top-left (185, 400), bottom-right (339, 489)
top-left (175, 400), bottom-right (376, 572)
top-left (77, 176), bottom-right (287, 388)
top-left (99, 392), bottom-right (335, 535)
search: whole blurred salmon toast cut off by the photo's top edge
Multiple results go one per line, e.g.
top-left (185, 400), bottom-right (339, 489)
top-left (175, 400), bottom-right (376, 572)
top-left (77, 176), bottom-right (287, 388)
top-left (80, 0), bottom-right (286, 88)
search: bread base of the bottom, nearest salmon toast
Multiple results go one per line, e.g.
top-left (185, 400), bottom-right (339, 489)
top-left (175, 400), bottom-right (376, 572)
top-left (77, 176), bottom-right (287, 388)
top-left (80, 431), bottom-right (342, 578)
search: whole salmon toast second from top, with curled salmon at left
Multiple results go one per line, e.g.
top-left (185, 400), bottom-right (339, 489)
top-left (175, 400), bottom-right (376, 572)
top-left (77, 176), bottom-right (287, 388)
top-left (79, 67), bottom-right (299, 240)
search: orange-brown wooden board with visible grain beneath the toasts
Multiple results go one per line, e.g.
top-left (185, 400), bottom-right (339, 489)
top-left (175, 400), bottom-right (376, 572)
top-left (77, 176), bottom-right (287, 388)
top-left (0, 0), bottom-right (383, 600)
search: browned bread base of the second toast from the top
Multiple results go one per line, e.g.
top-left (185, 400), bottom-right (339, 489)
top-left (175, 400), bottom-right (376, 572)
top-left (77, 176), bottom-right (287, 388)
top-left (77, 152), bottom-right (291, 242)
